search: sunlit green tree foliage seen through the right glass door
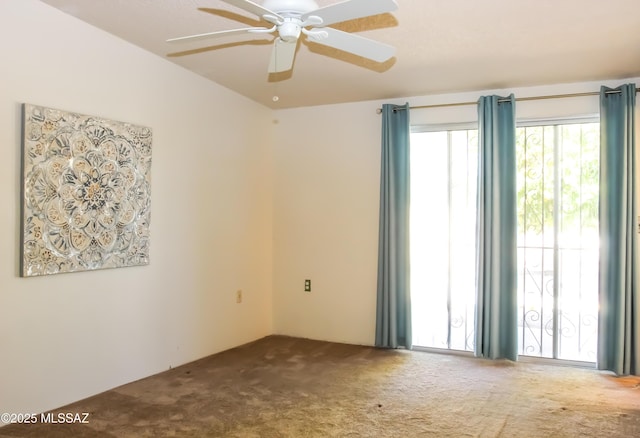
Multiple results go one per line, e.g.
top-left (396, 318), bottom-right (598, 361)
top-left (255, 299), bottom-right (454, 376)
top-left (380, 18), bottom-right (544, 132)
top-left (516, 123), bottom-right (600, 240)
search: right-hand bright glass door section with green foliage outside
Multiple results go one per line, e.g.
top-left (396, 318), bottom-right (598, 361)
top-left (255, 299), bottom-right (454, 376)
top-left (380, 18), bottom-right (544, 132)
top-left (516, 123), bottom-right (600, 362)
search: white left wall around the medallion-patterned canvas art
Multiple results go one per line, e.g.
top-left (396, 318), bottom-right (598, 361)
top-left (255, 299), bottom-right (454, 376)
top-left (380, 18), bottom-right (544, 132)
top-left (0, 0), bottom-right (272, 413)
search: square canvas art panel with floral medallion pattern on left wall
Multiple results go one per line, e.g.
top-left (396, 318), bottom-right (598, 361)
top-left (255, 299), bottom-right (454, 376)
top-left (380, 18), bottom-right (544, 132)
top-left (22, 104), bottom-right (152, 277)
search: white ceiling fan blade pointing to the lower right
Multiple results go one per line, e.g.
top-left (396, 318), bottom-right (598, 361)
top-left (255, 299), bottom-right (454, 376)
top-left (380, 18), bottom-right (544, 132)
top-left (308, 27), bottom-right (396, 62)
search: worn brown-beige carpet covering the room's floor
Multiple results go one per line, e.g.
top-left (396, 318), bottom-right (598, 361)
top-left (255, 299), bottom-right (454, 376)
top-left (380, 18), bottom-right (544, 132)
top-left (0, 336), bottom-right (640, 438)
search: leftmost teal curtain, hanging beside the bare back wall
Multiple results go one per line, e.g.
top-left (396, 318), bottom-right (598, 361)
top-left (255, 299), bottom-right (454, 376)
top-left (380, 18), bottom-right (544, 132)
top-left (376, 104), bottom-right (411, 348)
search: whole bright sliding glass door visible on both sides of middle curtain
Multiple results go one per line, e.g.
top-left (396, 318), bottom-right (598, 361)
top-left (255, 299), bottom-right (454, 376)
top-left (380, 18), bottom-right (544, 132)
top-left (411, 123), bottom-right (599, 362)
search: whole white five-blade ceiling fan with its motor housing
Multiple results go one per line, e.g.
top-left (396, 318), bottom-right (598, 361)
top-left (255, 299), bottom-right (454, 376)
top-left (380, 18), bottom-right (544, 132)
top-left (167, 0), bottom-right (398, 73)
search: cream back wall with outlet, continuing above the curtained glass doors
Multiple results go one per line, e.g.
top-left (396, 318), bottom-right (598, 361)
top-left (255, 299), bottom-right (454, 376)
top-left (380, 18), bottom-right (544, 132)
top-left (273, 78), bottom-right (640, 345)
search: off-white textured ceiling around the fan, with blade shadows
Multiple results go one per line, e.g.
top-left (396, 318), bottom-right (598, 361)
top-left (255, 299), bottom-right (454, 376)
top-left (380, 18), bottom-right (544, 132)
top-left (42, 0), bottom-right (640, 108)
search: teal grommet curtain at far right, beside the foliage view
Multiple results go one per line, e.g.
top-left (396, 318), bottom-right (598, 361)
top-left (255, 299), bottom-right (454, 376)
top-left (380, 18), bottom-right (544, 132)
top-left (598, 84), bottom-right (640, 375)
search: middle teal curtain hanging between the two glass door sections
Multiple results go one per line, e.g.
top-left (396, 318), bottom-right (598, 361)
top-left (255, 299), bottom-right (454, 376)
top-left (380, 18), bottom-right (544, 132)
top-left (475, 95), bottom-right (518, 360)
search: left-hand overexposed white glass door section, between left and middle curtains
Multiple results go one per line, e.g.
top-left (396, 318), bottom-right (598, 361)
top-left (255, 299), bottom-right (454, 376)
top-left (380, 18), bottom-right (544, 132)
top-left (411, 130), bottom-right (478, 351)
